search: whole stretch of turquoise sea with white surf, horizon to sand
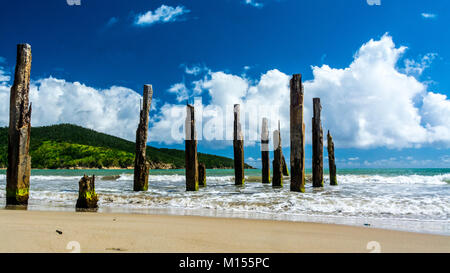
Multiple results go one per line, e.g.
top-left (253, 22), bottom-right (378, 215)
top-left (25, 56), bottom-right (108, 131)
top-left (0, 169), bottom-right (450, 235)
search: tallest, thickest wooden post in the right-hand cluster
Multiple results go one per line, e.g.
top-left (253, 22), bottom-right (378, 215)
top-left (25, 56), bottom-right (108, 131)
top-left (290, 74), bottom-right (306, 192)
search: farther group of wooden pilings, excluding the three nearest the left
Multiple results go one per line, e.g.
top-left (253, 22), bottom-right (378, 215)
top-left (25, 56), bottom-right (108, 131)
top-left (178, 74), bottom-right (337, 192)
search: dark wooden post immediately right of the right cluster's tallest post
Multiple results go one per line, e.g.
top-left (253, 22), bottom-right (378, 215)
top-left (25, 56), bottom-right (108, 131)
top-left (312, 98), bottom-right (323, 187)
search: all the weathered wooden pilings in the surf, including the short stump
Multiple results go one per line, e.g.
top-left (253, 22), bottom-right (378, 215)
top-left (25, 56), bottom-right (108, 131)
top-left (6, 44), bottom-right (337, 208)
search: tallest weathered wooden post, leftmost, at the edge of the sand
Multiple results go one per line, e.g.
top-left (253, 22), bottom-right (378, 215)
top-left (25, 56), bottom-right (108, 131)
top-left (6, 44), bottom-right (31, 205)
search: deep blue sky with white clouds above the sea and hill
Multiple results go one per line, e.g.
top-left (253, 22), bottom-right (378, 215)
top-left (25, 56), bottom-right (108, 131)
top-left (0, 0), bottom-right (450, 167)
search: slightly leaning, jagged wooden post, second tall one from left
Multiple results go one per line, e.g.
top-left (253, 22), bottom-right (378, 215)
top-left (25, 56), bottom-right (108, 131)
top-left (133, 85), bottom-right (153, 191)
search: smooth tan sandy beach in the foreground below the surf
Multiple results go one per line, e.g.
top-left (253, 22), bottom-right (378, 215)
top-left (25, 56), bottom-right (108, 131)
top-left (0, 210), bottom-right (450, 253)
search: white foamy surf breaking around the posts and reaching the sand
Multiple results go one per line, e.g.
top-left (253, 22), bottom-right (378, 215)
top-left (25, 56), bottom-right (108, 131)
top-left (0, 173), bottom-right (450, 232)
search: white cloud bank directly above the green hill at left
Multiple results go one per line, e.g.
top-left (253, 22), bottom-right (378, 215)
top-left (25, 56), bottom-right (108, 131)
top-left (0, 77), bottom-right (141, 140)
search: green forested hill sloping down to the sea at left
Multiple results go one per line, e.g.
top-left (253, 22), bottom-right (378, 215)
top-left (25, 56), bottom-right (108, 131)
top-left (0, 124), bottom-right (251, 169)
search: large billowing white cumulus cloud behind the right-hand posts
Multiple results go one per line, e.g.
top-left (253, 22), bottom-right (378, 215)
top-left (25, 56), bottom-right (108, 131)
top-left (151, 34), bottom-right (450, 148)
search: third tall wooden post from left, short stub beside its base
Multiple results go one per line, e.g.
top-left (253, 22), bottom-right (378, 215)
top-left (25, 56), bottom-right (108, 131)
top-left (185, 104), bottom-right (198, 191)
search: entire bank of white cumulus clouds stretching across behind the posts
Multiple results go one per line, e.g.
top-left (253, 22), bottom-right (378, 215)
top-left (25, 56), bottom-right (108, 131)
top-left (0, 34), bottom-right (450, 151)
